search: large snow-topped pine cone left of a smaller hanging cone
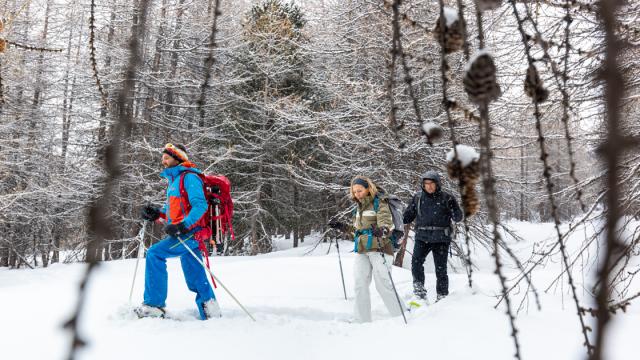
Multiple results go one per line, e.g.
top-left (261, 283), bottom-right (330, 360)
top-left (463, 53), bottom-right (502, 105)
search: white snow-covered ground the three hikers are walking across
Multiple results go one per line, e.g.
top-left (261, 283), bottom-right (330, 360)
top-left (0, 223), bottom-right (640, 360)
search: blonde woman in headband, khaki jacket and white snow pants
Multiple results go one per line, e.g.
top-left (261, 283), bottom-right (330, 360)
top-left (329, 176), bottom-right (402, 322)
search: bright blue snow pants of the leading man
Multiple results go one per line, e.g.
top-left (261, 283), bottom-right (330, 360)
top-left (144, 235), bottom-right (216, 320)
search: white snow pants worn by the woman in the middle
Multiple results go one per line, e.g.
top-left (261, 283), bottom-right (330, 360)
top-left (354, 251), bottom-right (401, 322)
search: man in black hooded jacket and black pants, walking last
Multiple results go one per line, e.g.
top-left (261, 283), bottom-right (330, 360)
top-left (403, 171), bottom-right (463, 300)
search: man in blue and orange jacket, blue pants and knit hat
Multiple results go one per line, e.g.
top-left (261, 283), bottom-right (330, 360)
top-left (134, 144), bottom-right (220, 320)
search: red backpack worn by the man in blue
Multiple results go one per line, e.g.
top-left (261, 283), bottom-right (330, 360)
top-left (180, 171), bottom-right (236, 245)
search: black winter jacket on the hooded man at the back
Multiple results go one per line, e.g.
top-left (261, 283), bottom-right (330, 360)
top-left (403, 190), bottom-right (463, 243)
